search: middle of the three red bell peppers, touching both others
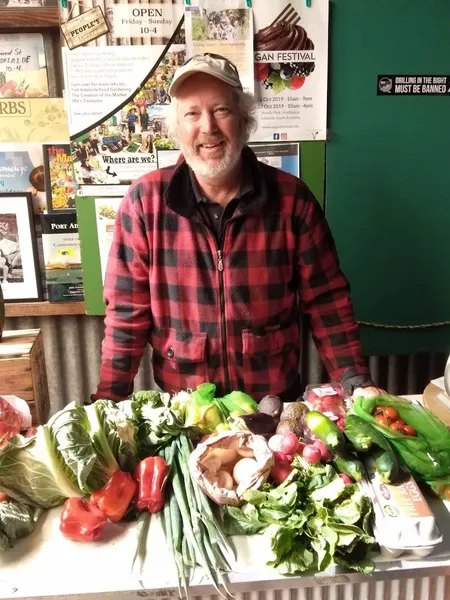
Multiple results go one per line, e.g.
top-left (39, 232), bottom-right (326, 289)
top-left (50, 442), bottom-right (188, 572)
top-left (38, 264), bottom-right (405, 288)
top-left (91, 471), bottom-right (137, 523)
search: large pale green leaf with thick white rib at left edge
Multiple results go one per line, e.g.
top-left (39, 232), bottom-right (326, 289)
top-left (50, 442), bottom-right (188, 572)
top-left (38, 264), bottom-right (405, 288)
top-left (0, 425), bottom-right (84, 508)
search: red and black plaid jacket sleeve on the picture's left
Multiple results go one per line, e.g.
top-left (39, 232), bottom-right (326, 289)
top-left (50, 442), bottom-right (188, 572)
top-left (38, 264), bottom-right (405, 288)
top-left (92, 185), bottom-right (152, 400)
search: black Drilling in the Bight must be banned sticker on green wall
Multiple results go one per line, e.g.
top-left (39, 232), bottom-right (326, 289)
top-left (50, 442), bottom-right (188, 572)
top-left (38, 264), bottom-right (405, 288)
top-left (377, 75), bottom-right (450, 96)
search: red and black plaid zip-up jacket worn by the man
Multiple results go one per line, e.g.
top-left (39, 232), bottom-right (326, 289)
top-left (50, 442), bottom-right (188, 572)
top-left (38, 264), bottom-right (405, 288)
top-left (96, 148), bottom-right (368, 400)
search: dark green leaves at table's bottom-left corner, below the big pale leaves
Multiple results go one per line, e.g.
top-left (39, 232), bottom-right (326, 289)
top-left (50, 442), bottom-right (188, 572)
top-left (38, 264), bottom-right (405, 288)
top-left (0, 500), bottom-right (42, 551)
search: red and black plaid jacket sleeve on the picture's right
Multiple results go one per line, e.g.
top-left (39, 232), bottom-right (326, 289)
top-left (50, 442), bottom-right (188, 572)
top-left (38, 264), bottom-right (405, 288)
top-left (296, 188), bottom-right (373, 393)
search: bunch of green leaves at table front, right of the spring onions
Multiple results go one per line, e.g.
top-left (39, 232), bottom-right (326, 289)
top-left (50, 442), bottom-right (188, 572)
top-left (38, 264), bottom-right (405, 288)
top-left (223, 459), bottom-right (375, 575)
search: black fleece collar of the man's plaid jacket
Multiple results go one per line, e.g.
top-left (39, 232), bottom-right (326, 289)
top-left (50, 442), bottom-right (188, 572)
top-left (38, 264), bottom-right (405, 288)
top-left (164, 146), bottom-right (268, 218)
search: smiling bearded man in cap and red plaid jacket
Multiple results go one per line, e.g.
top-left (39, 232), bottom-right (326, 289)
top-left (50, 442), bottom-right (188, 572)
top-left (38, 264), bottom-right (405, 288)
top-left (93, 54), bottom-right (380, 401)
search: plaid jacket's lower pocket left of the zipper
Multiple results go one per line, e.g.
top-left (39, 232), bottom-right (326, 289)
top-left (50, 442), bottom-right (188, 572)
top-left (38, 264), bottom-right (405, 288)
top-left (150, 328), bottom-right (208, 392)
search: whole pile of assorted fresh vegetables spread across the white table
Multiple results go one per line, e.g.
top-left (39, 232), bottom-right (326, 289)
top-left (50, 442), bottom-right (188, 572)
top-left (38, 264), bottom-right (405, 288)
top-left (0, 383), bottom-right (450, 596)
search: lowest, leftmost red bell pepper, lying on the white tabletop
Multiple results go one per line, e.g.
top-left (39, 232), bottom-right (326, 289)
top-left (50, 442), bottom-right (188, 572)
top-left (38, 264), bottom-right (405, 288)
top-left (59, 498), bottom-right (107, 542)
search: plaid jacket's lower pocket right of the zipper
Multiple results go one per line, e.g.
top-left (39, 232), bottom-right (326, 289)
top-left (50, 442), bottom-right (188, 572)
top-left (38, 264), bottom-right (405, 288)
top-left (242, 321), bottom-right (300, 398)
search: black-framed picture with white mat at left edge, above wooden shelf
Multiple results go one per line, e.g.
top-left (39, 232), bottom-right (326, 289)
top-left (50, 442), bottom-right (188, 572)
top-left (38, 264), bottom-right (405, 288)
top-left (0, 192), bottom-right (42, 302)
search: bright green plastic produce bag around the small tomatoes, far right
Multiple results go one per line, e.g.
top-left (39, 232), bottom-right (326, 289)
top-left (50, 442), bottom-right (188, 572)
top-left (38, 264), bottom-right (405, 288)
top-left (352, 394), bottom-right (450, 480)
